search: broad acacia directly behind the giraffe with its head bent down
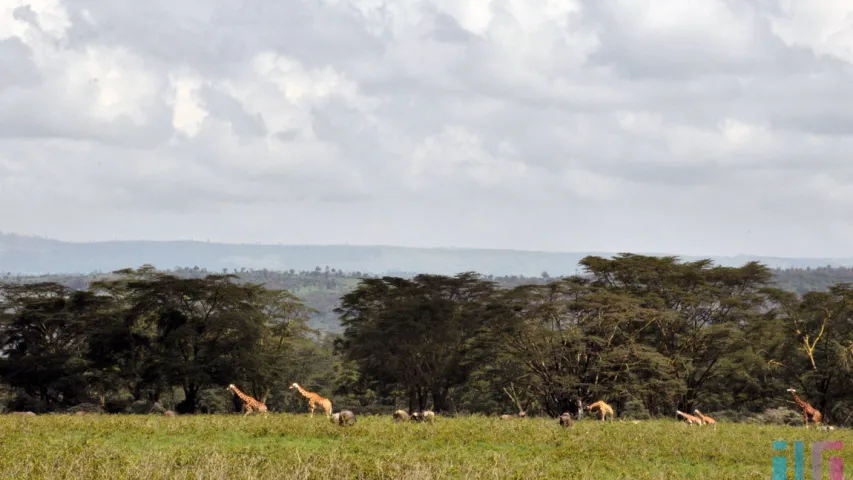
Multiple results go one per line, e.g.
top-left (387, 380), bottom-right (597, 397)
top-left (482, 277), bottom-right (674, 415)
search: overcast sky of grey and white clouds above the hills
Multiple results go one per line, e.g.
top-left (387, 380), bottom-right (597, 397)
top-left (0, 0), bottom-right (853, 256)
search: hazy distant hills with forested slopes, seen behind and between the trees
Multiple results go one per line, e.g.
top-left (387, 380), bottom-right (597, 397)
top-left (5, 231), bottom-right (853, 332)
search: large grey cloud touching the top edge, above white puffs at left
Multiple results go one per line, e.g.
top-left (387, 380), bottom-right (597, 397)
top-left (62, 0), bottom-right (383, 75)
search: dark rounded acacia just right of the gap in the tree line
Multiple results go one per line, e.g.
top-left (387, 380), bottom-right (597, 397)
top-left (336, 272), bottom-right (496, 411)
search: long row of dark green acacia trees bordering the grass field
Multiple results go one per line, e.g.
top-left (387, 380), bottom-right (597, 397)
top-left (0, 254), bottom-right (853, 424)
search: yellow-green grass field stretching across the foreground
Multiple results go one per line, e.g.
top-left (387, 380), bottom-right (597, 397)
top-left (0, 414), bottom-right (853, 480)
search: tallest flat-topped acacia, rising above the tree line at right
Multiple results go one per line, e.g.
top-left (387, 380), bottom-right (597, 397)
top-left (580, 254), bottom-right (771, 411)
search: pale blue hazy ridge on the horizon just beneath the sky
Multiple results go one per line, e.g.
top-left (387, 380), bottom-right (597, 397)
top-left (0, 234), bottom-right (853, 276)
